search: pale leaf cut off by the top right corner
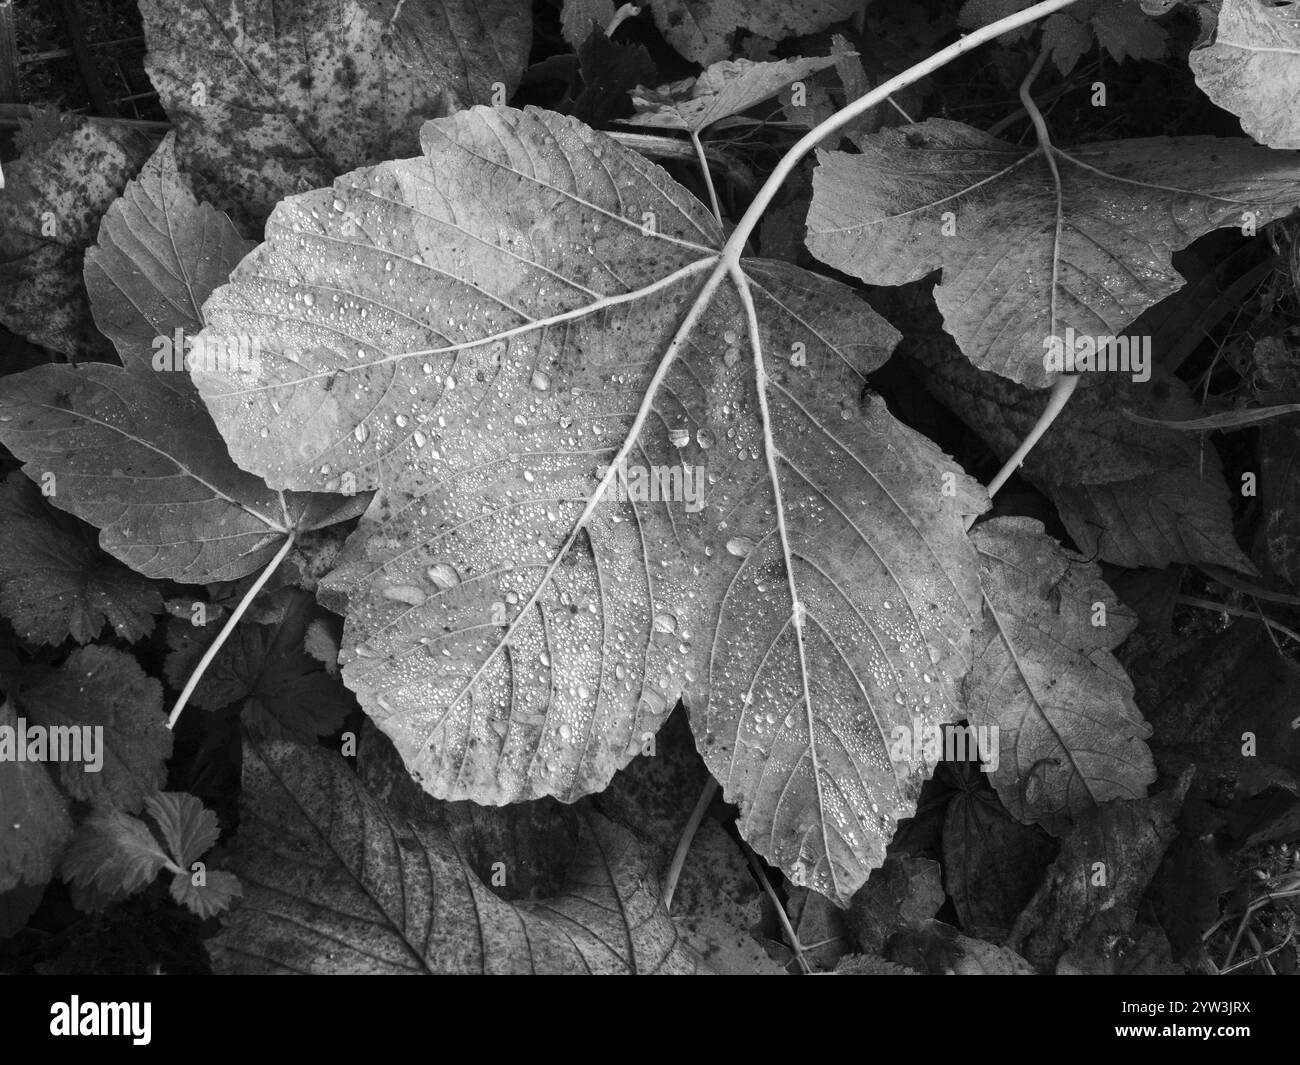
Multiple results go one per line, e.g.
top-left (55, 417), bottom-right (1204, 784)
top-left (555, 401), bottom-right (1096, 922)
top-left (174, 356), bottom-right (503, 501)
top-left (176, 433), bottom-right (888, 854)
top-left (1188, 0), bottom-right (1300, 148)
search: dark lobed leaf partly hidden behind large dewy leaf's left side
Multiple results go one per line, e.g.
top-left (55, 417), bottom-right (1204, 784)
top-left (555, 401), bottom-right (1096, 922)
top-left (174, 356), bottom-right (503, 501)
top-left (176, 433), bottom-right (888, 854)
top-left (0, 138), bottom-right (364, 583)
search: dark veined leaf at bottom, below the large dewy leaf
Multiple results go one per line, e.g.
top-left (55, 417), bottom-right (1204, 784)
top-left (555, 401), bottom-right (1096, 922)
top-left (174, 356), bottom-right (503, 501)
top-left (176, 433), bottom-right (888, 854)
top-left (208, 741), bottom-right (702, 974)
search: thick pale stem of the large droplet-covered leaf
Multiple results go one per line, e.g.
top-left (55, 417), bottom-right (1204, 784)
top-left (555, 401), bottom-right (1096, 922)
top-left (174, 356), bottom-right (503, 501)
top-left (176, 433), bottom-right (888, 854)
top-left (723, 0), bottom-right (1078, 263)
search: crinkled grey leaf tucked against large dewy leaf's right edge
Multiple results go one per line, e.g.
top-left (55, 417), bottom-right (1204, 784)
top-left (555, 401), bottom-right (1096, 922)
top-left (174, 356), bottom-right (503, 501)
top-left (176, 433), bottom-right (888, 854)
top-left (966, 518), bottom-right (1156, 835)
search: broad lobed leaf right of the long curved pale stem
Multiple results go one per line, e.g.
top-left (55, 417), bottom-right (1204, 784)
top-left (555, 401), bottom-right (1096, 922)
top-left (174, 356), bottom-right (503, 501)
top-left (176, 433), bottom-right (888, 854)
top-left (807, 118), bottom-right (1300, 388)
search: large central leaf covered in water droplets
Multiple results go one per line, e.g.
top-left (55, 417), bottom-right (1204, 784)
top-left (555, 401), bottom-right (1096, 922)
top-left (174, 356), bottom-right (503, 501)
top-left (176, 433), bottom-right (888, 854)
top-left (194, 108), bottom-right (987, 897)
